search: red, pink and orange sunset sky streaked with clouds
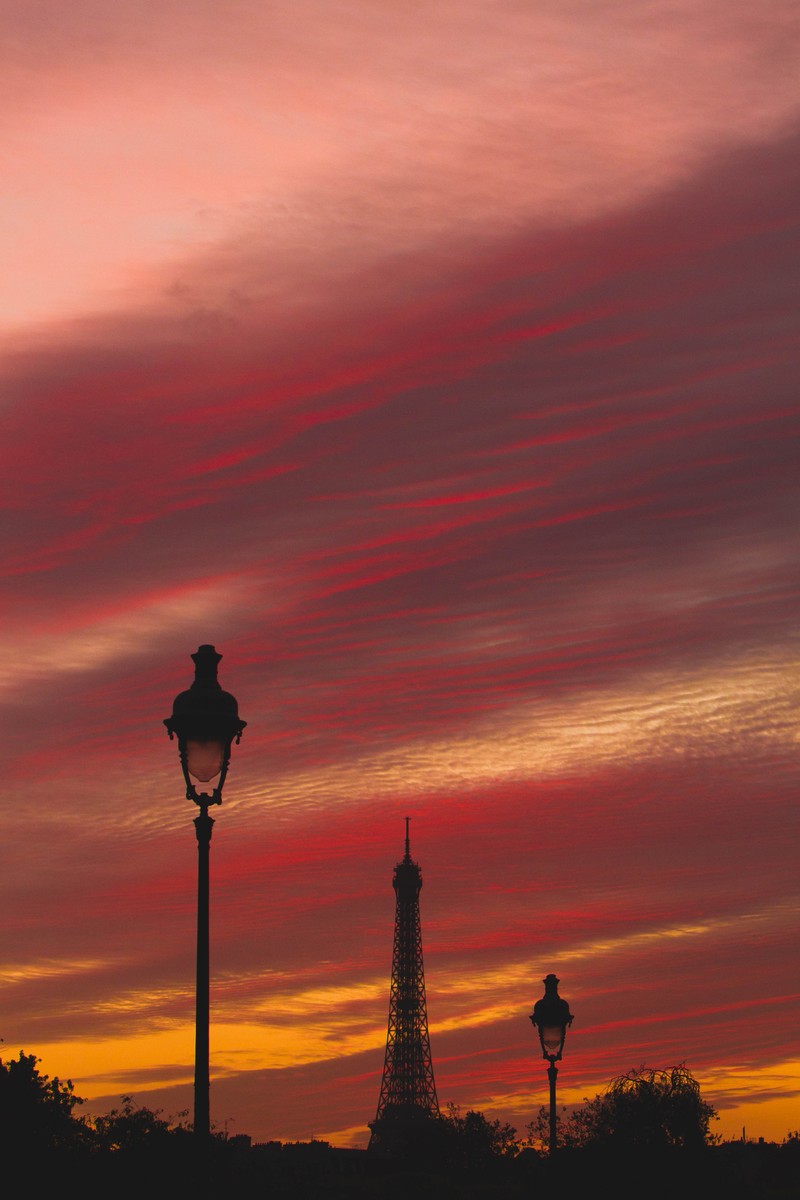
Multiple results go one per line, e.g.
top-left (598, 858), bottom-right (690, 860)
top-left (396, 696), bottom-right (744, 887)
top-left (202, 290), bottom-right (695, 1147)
top-left (0, 0), bottom-right (800, 1146)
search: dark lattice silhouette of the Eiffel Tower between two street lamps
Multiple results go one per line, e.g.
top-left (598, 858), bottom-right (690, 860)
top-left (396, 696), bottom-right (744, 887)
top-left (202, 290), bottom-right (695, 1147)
top-left (369, 817), bottom-right (439, 1145)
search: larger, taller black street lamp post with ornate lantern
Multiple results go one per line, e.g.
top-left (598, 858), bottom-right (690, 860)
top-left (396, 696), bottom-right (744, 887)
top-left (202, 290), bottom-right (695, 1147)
top-left (164, 646), bottom-right (247, 1145)
